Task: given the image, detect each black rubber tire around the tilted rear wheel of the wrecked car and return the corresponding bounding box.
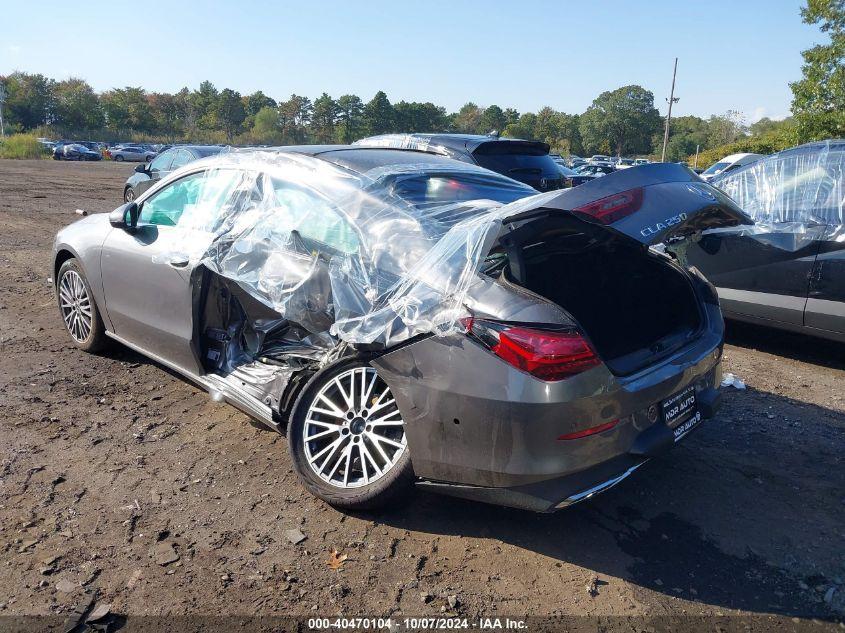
[287,360,415,511]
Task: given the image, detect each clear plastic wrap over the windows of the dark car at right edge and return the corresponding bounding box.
[712,141,845,228]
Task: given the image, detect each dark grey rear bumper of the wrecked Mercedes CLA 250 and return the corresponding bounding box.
[373,304,723,511]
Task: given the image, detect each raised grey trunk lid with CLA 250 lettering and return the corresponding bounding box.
[505,163,754,246]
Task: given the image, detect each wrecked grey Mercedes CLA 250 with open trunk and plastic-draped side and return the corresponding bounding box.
[52,146,750,511]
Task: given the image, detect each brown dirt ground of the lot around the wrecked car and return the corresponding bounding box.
[0,160,845,626]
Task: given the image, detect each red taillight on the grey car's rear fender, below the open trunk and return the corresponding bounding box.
[462,319,601,381]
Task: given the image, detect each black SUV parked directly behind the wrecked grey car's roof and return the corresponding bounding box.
[353,134,566,191]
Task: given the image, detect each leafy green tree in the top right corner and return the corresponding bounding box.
[790,0,845,140]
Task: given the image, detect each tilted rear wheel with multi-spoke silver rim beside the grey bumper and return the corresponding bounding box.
[288,361,413,510]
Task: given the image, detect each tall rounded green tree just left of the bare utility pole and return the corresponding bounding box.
[579,85,661,155]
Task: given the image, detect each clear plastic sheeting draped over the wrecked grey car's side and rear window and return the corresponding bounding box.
[152,151,544,355]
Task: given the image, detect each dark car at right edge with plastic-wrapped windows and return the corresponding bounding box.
[687,141,845,341]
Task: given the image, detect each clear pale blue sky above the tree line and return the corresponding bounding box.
[0,0,825,122]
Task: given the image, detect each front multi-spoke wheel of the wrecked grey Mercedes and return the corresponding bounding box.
[56,259,106,352]
